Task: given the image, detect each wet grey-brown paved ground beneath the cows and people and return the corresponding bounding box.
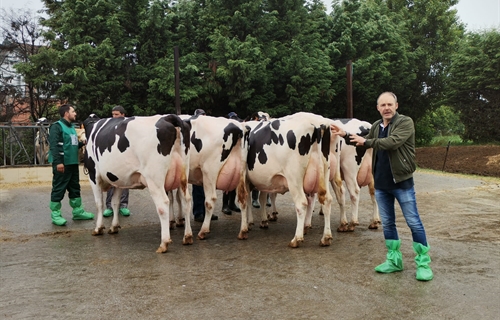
[0,171,500,319]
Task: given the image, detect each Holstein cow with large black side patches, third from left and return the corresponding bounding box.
[238,112,332,248]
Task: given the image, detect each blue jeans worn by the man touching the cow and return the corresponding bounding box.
[375,187,427,246]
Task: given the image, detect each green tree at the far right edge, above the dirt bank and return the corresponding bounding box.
[448,30,500,142]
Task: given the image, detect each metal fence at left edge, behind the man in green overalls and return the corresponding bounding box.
[0,122,50,167]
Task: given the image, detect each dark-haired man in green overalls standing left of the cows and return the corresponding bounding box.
[49,104,94,226]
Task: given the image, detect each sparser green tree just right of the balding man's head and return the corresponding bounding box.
[386,0,464,121]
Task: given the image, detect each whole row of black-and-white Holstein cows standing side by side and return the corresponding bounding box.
[45,112,380,253]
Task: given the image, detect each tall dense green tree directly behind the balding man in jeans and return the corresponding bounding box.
[329,1,416,121]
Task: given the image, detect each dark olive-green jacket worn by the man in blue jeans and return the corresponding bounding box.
[365,112,417,183]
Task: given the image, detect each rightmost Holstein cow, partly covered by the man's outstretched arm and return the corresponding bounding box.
[330,119,380,232]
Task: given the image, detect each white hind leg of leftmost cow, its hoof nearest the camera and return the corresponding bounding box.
[147,184,172,253]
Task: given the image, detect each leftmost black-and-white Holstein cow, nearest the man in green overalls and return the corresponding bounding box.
[84,114,193,253]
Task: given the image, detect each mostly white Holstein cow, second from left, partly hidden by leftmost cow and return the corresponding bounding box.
[172,115,247,240]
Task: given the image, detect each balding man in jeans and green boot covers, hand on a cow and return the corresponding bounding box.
[331,92,433,281]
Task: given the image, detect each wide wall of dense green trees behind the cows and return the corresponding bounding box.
[3,0,463,122]
